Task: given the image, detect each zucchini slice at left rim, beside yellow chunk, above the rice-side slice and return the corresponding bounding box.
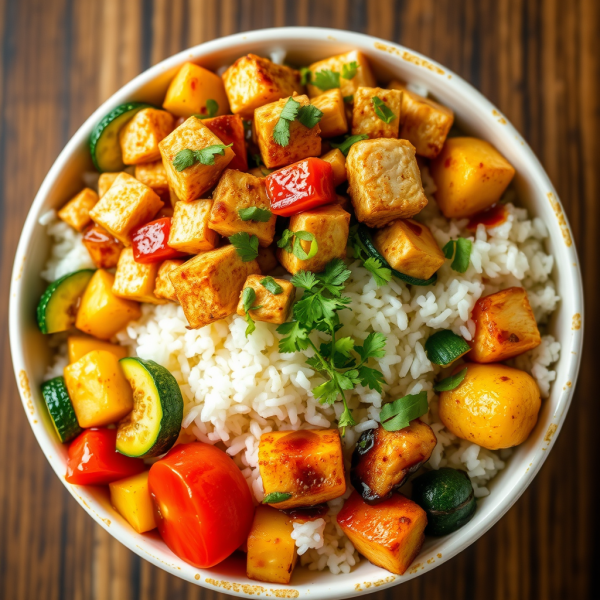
[37,269,95,333]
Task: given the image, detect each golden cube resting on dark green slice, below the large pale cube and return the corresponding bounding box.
[373,219,446,279]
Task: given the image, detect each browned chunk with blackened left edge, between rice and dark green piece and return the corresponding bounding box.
[350,419,437,504]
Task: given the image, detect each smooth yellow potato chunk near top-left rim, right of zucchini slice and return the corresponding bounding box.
[163,63,229,119]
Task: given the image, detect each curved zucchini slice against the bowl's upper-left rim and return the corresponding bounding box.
[90,102,154,173]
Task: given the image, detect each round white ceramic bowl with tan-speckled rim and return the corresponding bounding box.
[10,27,583,600]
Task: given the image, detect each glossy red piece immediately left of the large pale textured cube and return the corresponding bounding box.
[265,158,337,217]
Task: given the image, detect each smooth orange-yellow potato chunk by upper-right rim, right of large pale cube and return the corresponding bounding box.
[430,137,515,219]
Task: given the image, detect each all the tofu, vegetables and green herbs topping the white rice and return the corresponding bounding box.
[37,51,540,584]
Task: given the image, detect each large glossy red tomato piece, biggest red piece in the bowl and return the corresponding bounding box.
[148,442,254,569]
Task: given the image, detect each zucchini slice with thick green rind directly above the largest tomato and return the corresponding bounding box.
[117,357,183,457]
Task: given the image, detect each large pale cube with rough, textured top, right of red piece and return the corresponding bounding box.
[346,138,427,227]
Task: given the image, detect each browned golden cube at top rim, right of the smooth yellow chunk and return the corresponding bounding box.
[223,54,302,119]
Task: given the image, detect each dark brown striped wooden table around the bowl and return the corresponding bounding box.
[0,0,600,600]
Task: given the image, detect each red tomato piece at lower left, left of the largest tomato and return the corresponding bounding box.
[65,428,146,485]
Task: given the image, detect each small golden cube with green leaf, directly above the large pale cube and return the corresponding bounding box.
[352,88,402,139]
